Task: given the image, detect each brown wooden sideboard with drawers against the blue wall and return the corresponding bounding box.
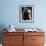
[2,32,44,46]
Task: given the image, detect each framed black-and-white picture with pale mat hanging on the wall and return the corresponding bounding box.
[19,5,34,23]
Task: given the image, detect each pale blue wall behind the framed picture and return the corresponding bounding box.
[0,0,46,31]
